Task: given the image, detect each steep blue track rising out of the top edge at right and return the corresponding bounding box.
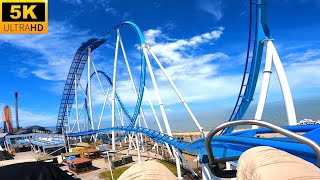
[222,0,271,134]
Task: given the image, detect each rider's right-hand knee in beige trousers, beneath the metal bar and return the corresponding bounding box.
[237,146,320,180]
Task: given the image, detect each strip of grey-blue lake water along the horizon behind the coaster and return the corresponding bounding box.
[47,100,320,132]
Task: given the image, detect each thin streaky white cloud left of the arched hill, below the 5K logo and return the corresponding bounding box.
[0,21,89,81]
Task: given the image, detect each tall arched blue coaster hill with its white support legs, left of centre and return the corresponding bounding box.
[57,21,204,177]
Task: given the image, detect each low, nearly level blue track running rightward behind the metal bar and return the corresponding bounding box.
[68,125,320,164]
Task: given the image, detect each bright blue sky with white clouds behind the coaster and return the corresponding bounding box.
[0,0,320,130]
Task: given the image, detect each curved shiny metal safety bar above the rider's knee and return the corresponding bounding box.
[205,120,320,177]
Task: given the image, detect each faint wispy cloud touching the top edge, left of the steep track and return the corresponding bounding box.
[197,0,223,20]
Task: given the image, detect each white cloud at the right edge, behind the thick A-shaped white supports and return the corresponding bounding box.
[255,49,320,102]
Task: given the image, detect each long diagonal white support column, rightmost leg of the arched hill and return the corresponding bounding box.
[146,45,205,137]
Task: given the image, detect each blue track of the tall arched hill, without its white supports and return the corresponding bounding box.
[56,21,146,134]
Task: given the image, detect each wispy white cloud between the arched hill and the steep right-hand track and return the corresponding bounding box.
[107,27,241,105]
